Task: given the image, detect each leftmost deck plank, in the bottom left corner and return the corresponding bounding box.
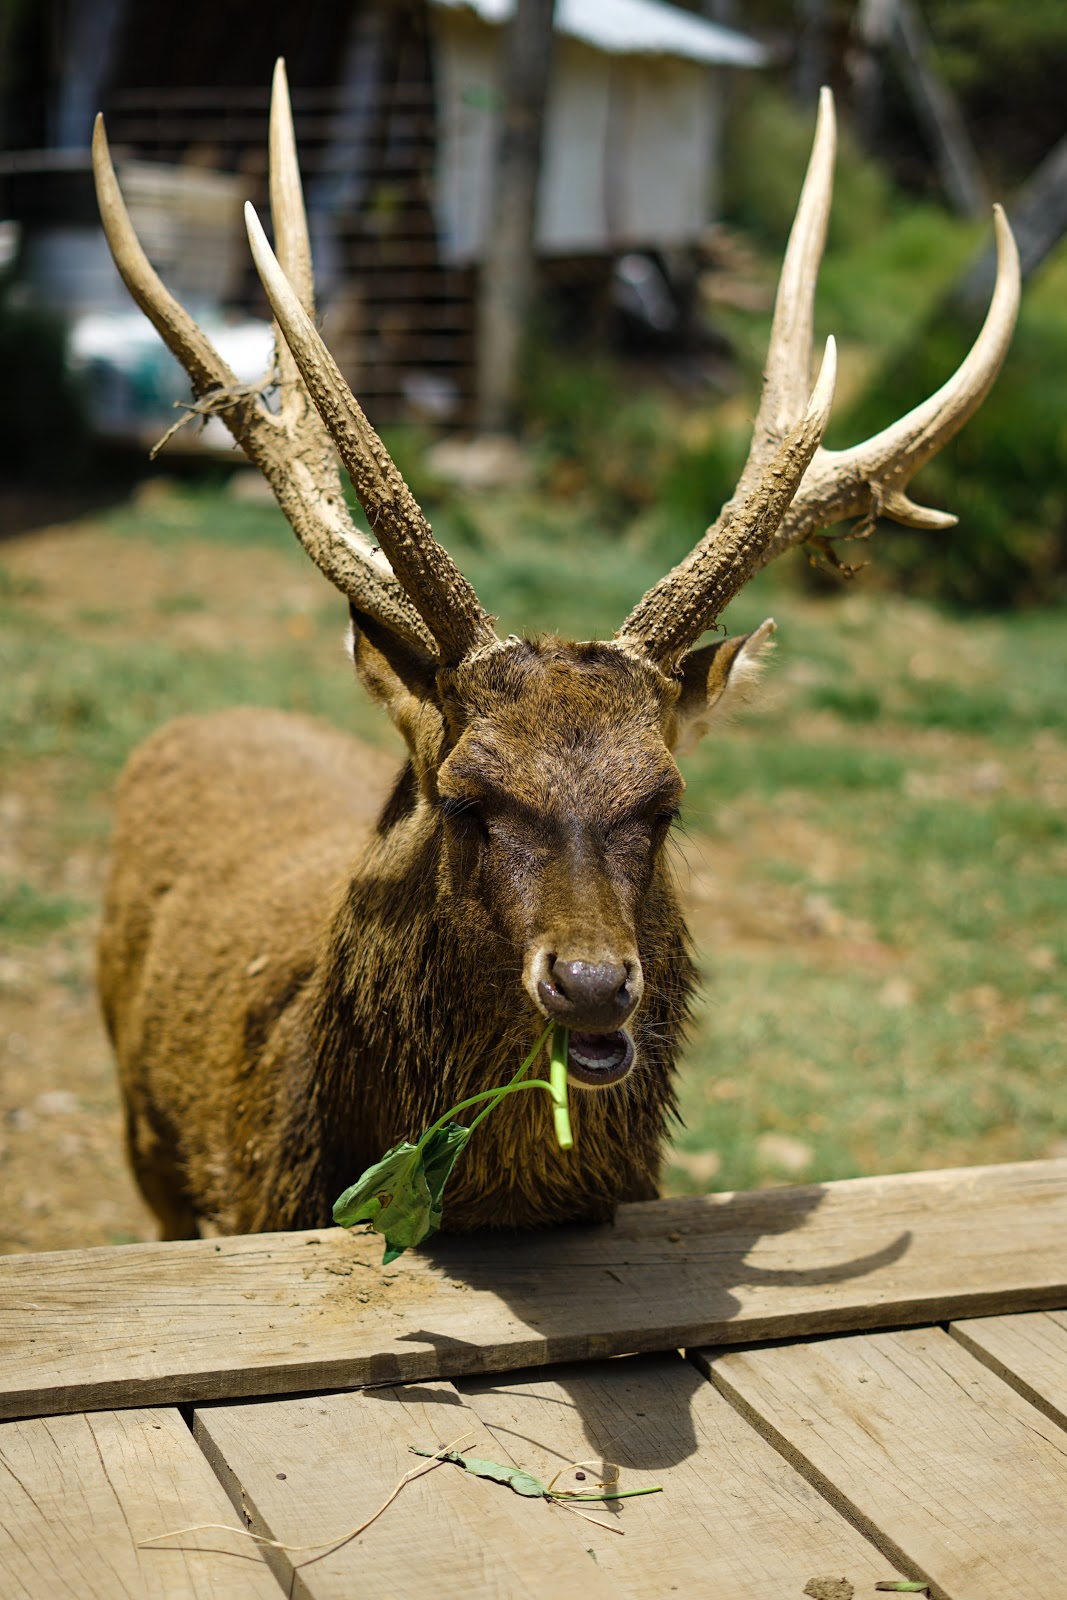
[0,1410,280,1600]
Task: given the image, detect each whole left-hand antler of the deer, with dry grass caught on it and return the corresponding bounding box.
[93,61,496,664]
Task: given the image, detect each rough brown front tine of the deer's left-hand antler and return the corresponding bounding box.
[245,205,496,664]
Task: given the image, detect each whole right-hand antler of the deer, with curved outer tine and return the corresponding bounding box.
[617,90,1019,669]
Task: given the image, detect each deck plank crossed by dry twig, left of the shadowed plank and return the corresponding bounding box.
[195,1382,622,1600]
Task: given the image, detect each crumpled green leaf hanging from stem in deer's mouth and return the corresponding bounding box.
[333,1122,470,1266]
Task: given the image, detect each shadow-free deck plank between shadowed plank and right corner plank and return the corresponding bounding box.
[704,1328,1067,1600]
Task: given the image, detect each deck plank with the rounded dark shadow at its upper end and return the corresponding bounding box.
[461,1354,894,1600]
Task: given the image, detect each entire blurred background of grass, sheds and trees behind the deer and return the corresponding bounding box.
[0,0,1067,1250]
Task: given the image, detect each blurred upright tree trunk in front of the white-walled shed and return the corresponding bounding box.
[477,0,555,434]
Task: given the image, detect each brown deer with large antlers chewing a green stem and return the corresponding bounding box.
[94,64,1019,1238]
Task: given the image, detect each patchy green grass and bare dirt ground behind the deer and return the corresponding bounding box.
[0,480,1067,1250]
